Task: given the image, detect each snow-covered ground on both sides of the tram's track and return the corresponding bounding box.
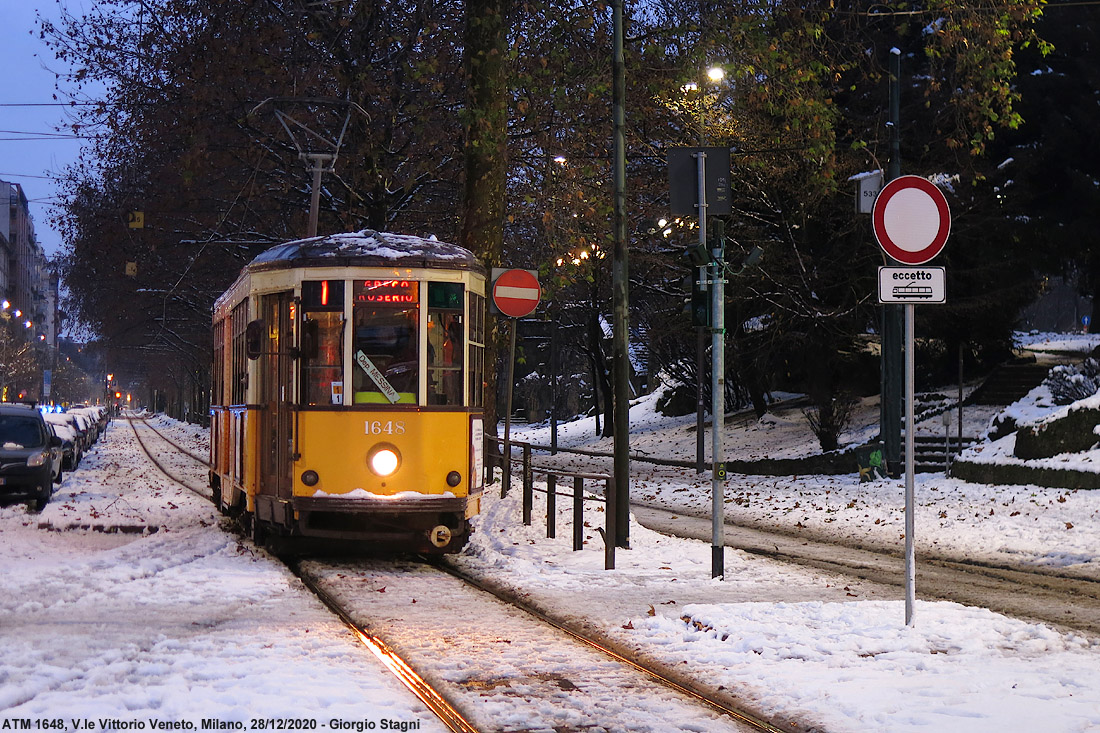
[0,334,1100,733]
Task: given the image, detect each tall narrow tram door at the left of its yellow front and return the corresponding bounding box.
[260,291,294,499]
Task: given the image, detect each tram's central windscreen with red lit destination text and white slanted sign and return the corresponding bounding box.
[351,280,420,405]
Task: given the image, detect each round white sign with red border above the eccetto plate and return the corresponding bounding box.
[871,176,952,265]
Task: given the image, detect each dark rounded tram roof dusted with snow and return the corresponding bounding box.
[249,229,479,269]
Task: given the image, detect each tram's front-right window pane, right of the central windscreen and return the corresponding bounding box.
[428,283,465,405]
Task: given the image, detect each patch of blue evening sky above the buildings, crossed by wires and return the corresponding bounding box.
[0,0,89,256]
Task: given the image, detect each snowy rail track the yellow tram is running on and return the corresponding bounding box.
[130,420,792,733]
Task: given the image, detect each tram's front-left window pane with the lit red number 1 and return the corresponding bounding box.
[301,280,344,405]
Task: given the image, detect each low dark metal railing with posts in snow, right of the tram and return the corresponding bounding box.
[485,436,615,570]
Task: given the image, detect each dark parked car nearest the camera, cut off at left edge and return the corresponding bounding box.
[0,403,63,512]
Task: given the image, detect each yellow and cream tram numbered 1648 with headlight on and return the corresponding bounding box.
[210,230,485,553]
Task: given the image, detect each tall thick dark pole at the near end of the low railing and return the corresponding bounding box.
[607,0,630,548]
